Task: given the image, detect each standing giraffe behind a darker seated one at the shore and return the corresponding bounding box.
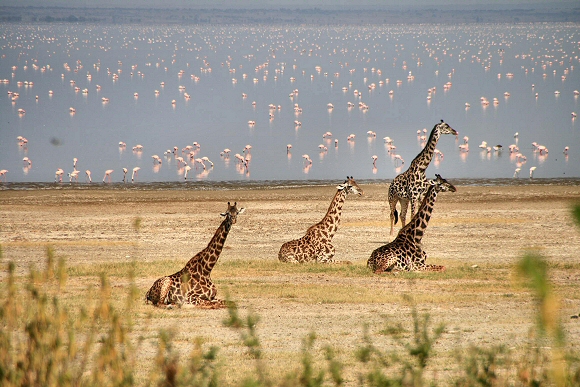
[388,120,459,235]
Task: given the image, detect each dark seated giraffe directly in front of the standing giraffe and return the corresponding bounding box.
[367,175,456,273]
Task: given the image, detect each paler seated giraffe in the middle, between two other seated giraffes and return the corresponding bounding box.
[278,176,364,263]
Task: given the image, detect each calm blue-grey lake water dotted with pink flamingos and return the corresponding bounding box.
[0,23,580,183]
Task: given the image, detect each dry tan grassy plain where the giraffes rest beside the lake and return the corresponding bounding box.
[0,181,580,385]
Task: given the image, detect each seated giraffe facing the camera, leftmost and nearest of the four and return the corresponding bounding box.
[145,202,245,309]
